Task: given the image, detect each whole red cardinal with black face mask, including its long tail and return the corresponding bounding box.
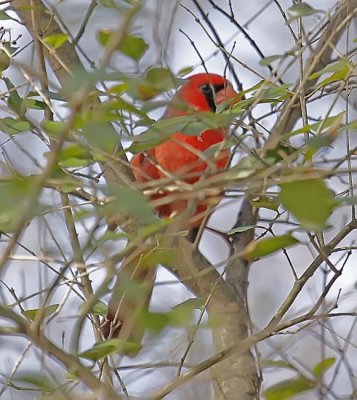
[102,73,239,342]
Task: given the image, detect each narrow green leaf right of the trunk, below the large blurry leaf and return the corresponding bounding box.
[244,233,299,260]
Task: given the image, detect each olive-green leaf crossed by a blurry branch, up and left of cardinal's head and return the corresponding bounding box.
[98,29,149,61]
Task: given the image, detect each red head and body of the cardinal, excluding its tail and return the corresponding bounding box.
[131,73,238,228]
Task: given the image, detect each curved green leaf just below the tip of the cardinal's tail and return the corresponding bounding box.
[79,339,141,361]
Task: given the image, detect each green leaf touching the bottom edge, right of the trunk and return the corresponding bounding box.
[263,377,315,400]
